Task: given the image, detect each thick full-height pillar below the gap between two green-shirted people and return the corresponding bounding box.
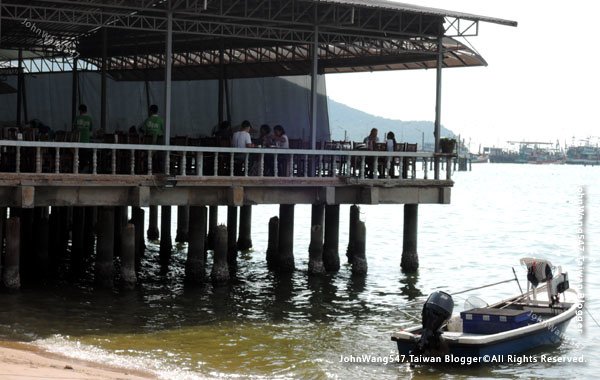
[96,207,115,288]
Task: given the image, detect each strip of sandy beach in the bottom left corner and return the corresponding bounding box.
[0,341,156,380]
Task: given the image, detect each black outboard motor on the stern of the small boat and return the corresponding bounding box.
[412,291,454,355]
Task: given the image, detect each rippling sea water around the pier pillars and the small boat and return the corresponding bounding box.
[0,164,600,379]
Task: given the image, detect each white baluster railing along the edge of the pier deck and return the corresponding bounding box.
[0,140,453,180]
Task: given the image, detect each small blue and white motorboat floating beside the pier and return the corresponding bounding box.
[392,258,583,365]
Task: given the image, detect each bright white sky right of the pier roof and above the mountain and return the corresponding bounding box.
[326,0,600,150]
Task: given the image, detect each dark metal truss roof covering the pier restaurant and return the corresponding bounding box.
[0,0,516,80]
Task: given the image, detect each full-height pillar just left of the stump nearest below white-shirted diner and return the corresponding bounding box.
[185,206,206,283]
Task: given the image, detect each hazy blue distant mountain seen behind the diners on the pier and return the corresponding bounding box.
[327,98,455,146]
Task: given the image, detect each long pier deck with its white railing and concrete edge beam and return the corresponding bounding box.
[0,140,453,208]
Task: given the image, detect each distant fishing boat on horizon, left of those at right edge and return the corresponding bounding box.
[489,141,566,164]
